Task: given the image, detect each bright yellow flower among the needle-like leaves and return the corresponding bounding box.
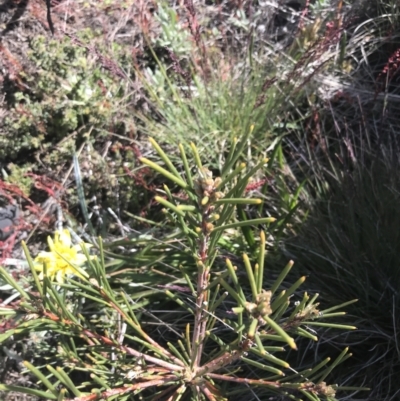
[34,230,91,283]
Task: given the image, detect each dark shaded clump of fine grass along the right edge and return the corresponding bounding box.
[287,144,400,400]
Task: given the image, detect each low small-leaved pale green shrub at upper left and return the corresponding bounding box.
[0,31,121,158]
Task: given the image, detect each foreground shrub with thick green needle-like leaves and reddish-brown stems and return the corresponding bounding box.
[0,136,362,401]
